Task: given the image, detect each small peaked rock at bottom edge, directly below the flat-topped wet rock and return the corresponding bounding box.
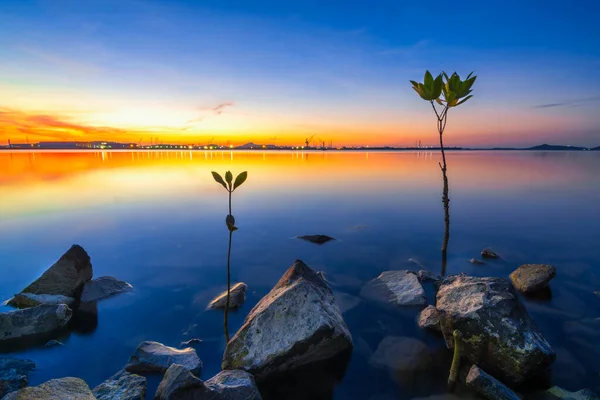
[154,364,205,400]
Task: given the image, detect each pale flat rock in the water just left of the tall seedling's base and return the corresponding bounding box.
[360,270,427,306]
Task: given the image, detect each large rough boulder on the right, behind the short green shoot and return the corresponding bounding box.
[436,275,555,383]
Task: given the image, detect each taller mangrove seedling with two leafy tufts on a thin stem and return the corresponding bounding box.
[410,71,477,275]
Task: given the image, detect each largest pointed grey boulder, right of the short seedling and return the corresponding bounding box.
[222,260,352,380]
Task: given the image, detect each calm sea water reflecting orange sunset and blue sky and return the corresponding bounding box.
[0,151,600,399]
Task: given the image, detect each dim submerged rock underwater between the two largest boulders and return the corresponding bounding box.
[369,336,432,374]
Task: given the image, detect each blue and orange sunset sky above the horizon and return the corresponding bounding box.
[0,0,600,147]
